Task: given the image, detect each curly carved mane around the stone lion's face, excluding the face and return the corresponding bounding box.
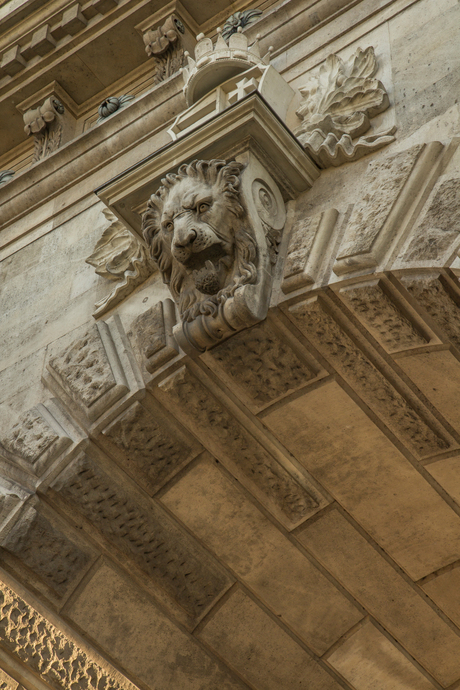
[142,160,257,321]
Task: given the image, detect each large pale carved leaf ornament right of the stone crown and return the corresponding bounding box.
[295,46,395,168]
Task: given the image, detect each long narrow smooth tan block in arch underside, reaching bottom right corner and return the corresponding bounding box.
[299,510,460,688]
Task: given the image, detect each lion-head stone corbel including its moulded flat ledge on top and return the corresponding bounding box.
[98,91,319,356]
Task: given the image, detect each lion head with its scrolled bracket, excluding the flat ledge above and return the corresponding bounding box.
[142,153,285,355]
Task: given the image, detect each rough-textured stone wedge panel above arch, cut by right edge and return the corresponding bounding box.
[404,179,460,261]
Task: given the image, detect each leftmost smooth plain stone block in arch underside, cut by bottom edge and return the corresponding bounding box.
[67,566,247,690]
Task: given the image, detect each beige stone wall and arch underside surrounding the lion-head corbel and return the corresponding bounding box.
[0,0,460,690]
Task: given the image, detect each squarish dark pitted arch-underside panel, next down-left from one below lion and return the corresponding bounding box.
[103,402,191,493]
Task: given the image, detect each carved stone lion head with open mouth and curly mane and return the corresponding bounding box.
[142,160,257,322]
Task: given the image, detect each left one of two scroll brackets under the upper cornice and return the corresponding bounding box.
[23,96,64,163]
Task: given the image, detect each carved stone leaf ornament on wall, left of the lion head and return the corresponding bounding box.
[86,208,156,316]
